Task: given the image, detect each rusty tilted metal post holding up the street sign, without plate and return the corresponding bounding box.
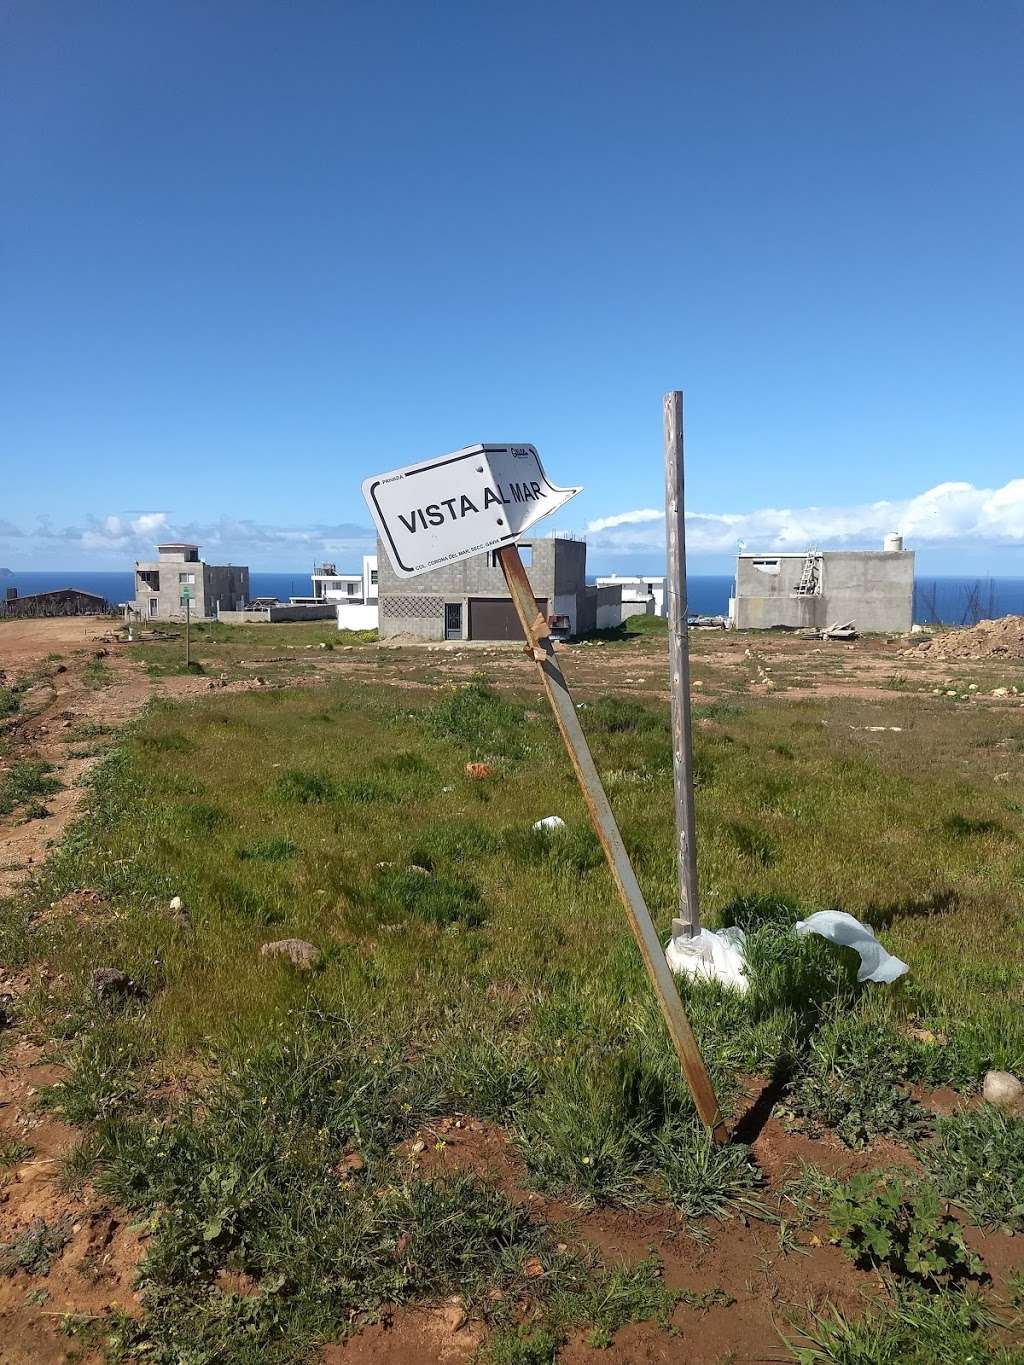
[497,545,728,1143]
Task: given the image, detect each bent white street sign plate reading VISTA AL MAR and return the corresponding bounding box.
[363,445,580,579]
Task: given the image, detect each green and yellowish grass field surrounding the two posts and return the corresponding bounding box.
[3,666,1024,1365]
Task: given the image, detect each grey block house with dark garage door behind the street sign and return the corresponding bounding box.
[377,536,621,640]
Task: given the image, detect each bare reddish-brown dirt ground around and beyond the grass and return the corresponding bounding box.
[0,618,1024,1365]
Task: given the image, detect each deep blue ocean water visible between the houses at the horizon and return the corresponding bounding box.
[0,569,1024,625]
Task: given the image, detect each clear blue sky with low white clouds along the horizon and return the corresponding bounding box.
[0,0,1024,573]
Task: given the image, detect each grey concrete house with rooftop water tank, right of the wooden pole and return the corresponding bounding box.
[729,535,913,631]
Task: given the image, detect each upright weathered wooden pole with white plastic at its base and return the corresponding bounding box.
[662,389,700,938]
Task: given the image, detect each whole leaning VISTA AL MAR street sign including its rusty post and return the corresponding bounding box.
[363,444,726,1143]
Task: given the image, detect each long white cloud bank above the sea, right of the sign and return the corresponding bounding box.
[586,479,1024,554]
